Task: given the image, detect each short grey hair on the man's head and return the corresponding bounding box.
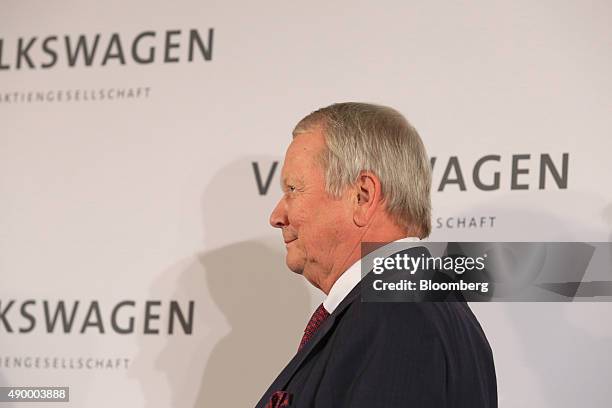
[293,102,431,238]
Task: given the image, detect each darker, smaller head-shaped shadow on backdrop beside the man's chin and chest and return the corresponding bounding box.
[194,243,310,408]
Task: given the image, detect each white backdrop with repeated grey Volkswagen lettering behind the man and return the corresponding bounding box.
[0,0,612,408]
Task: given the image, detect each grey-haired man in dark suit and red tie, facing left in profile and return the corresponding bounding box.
[257,103,497,408]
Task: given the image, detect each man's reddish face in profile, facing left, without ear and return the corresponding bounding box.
[270,128,352,287]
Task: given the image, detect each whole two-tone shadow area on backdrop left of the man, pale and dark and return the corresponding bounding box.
[130,157,312,408]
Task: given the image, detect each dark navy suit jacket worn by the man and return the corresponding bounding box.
[257,247,497,408]
